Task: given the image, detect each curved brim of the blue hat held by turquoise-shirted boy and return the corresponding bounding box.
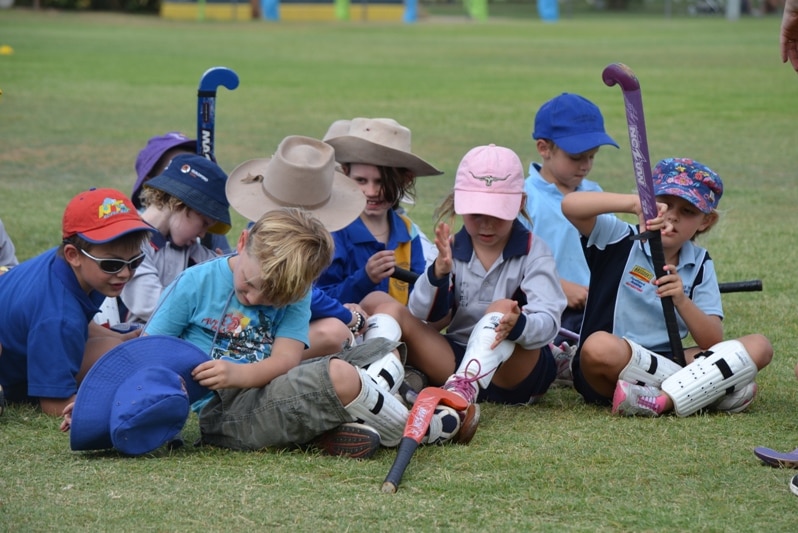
[69,335,210,451]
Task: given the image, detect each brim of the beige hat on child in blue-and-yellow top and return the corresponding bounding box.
[324,135,443,177]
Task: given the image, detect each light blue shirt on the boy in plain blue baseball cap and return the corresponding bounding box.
[519,163,601,287]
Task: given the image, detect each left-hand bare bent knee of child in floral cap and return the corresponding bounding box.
[579,331,632,398]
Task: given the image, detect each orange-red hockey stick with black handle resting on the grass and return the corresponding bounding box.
[382,387,468,493]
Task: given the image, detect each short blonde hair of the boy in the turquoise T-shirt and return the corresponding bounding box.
[244,207,334,307]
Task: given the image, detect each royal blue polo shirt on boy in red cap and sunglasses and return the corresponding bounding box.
[0,248,105,401]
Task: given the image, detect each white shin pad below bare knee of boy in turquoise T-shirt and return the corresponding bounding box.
[345,369,408,447]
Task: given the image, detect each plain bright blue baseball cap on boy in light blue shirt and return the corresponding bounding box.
[532,93,618,154]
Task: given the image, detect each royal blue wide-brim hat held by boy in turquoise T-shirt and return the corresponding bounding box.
[69,335,209,455]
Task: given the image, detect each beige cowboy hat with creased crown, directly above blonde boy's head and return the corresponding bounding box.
[226,135,366,231]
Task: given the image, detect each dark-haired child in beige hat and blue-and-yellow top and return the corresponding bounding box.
[318,118,443,311]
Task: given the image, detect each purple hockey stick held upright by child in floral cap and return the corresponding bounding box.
[601,63,684,365]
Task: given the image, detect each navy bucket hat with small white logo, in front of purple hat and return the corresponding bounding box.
[144,154,231,235]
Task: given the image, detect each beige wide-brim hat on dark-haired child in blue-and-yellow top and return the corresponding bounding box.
[325,118,443,177]
